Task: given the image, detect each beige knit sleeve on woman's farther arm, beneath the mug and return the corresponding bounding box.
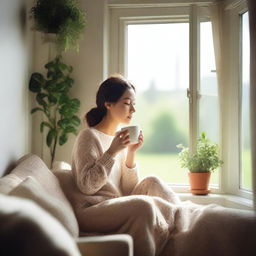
[121,153,139,195]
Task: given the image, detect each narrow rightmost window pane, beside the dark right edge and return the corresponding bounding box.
[240,12,252,190]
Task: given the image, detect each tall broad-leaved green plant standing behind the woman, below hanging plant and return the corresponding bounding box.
[29,55,80,167]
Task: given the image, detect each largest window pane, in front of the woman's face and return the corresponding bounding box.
[127,23,189,184]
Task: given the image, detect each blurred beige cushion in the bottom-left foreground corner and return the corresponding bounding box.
[0,194,80,256]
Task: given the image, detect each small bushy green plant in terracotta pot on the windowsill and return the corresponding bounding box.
[177,132,223,195]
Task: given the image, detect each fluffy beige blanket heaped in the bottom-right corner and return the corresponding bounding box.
[161,201,256,256]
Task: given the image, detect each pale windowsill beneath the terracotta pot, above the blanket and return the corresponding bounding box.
[178,193,253,210]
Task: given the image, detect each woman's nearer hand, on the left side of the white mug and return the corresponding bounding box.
[107,130,130,157]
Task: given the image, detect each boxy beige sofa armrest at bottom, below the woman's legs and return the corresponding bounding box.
[76,234,133,256]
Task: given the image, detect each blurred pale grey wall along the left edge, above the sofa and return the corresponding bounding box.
[0,0,32,176]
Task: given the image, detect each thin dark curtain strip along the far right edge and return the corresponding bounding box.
[248,0,256,211]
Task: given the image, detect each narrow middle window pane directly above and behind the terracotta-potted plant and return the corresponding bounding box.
[199,22,219,185]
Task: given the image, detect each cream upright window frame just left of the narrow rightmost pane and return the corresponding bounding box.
[223,0,253,200]
